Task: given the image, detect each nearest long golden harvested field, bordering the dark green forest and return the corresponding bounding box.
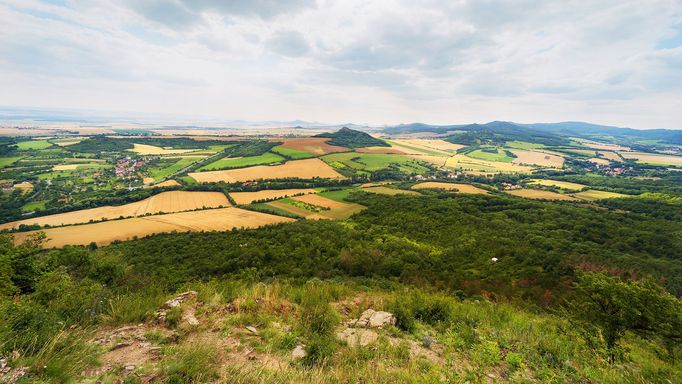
[15,208,293,248]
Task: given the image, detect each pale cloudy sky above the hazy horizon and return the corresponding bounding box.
[0,0,682,129]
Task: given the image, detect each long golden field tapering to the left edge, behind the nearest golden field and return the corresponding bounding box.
[0,191,230,230]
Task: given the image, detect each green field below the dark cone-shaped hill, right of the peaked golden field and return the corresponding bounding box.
[321,152,427,173]
